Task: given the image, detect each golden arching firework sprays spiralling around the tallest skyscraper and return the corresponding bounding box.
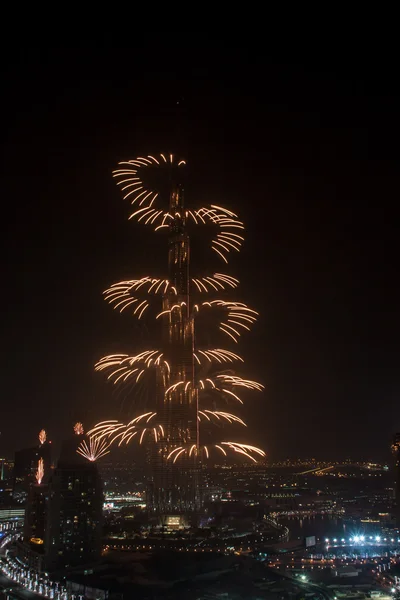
[90,154,265,464]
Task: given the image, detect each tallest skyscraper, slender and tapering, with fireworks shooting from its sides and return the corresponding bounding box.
[148,182,200,515]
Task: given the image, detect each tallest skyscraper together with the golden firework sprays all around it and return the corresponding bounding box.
[89,154,265,522]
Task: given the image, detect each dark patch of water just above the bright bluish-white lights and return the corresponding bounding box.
[279,515,358,540]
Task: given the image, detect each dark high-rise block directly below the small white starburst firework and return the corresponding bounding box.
[45,436,103,571]
